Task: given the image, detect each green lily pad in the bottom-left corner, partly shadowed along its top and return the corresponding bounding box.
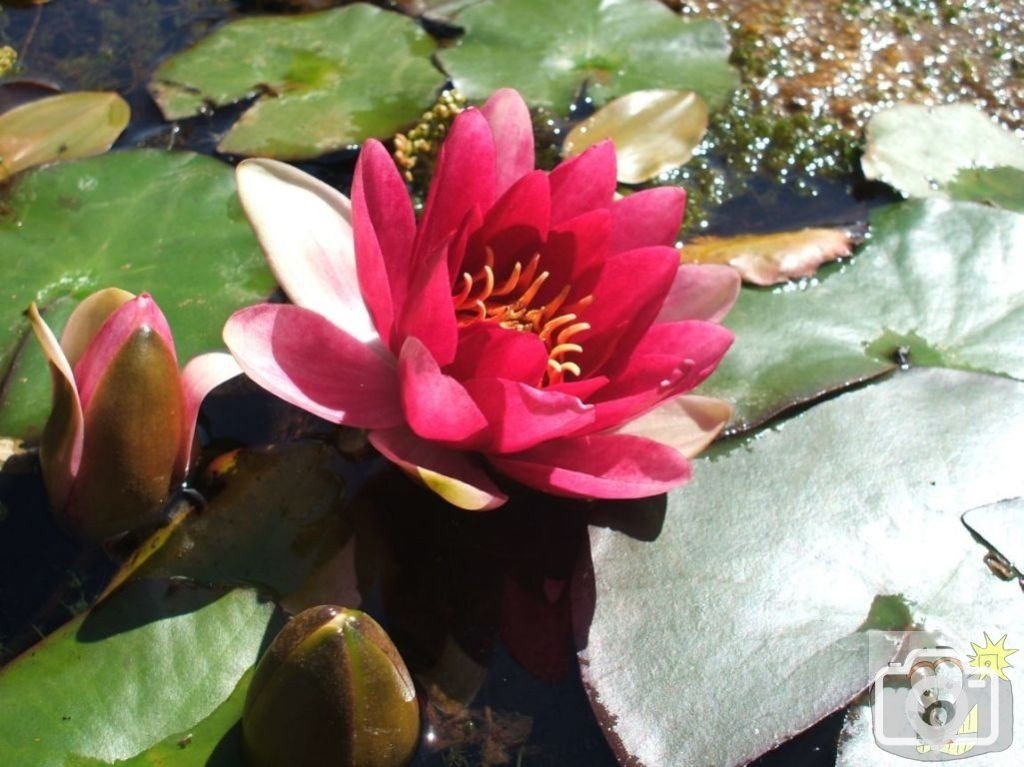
[0,581,274,767]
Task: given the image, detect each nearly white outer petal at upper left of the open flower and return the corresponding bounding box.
[236,160,377,341]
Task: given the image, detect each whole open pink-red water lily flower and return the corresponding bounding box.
[224,90,738,509]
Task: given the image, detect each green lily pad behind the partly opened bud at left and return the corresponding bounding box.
[0,151,274,437]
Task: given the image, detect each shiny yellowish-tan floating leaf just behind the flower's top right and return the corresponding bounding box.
[562,90,708,183]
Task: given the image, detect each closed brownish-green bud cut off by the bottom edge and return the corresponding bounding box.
[242,605,420,767]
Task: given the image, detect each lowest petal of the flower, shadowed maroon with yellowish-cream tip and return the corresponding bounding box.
[370,426,508,511]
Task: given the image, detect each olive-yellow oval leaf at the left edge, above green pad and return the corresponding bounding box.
[0,92,131,181]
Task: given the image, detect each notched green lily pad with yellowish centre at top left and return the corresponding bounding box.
[150,3,444,160]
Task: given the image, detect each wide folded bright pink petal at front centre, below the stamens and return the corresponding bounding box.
[465,378,594,453]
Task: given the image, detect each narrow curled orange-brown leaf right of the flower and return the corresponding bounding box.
[681,228,851,286]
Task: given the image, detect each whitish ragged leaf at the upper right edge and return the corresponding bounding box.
[860,103,1024,197]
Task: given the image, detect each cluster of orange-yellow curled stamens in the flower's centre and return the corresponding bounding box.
[452,248,594,386]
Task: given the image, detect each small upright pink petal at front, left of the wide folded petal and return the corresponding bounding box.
[398,338,487,448]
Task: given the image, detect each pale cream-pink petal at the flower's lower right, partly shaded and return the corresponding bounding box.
[615,394,732,458]
